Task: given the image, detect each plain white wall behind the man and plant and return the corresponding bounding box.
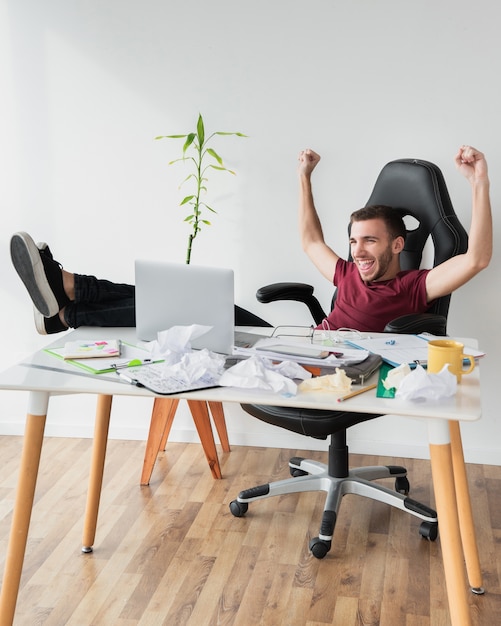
[0,0,501,464]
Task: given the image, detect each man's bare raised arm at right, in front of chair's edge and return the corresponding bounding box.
[426,146,492,302]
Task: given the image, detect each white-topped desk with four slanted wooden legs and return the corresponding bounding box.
[0,328,482,626]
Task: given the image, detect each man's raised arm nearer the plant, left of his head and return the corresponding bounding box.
[298,149,339,282]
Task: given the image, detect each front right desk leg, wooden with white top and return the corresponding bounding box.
[430,420,471,626]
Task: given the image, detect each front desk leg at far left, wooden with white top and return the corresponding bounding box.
[0,391,49,626]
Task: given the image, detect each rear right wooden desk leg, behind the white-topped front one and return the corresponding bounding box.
[449,421,485,594]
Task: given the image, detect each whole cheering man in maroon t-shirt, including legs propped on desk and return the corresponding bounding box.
[11,146,492,334]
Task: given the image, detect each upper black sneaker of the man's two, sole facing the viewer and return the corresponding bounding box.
[10,232,70,318]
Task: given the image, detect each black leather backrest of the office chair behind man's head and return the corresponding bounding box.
[338,159,468,317]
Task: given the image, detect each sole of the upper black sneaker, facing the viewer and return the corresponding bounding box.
[10,232,59,317]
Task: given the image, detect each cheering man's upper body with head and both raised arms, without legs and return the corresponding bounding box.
[298,146,492,332]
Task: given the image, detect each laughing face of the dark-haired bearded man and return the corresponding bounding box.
[350,219,404,282]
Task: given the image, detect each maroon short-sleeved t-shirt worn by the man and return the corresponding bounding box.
[319,259,430,333]
